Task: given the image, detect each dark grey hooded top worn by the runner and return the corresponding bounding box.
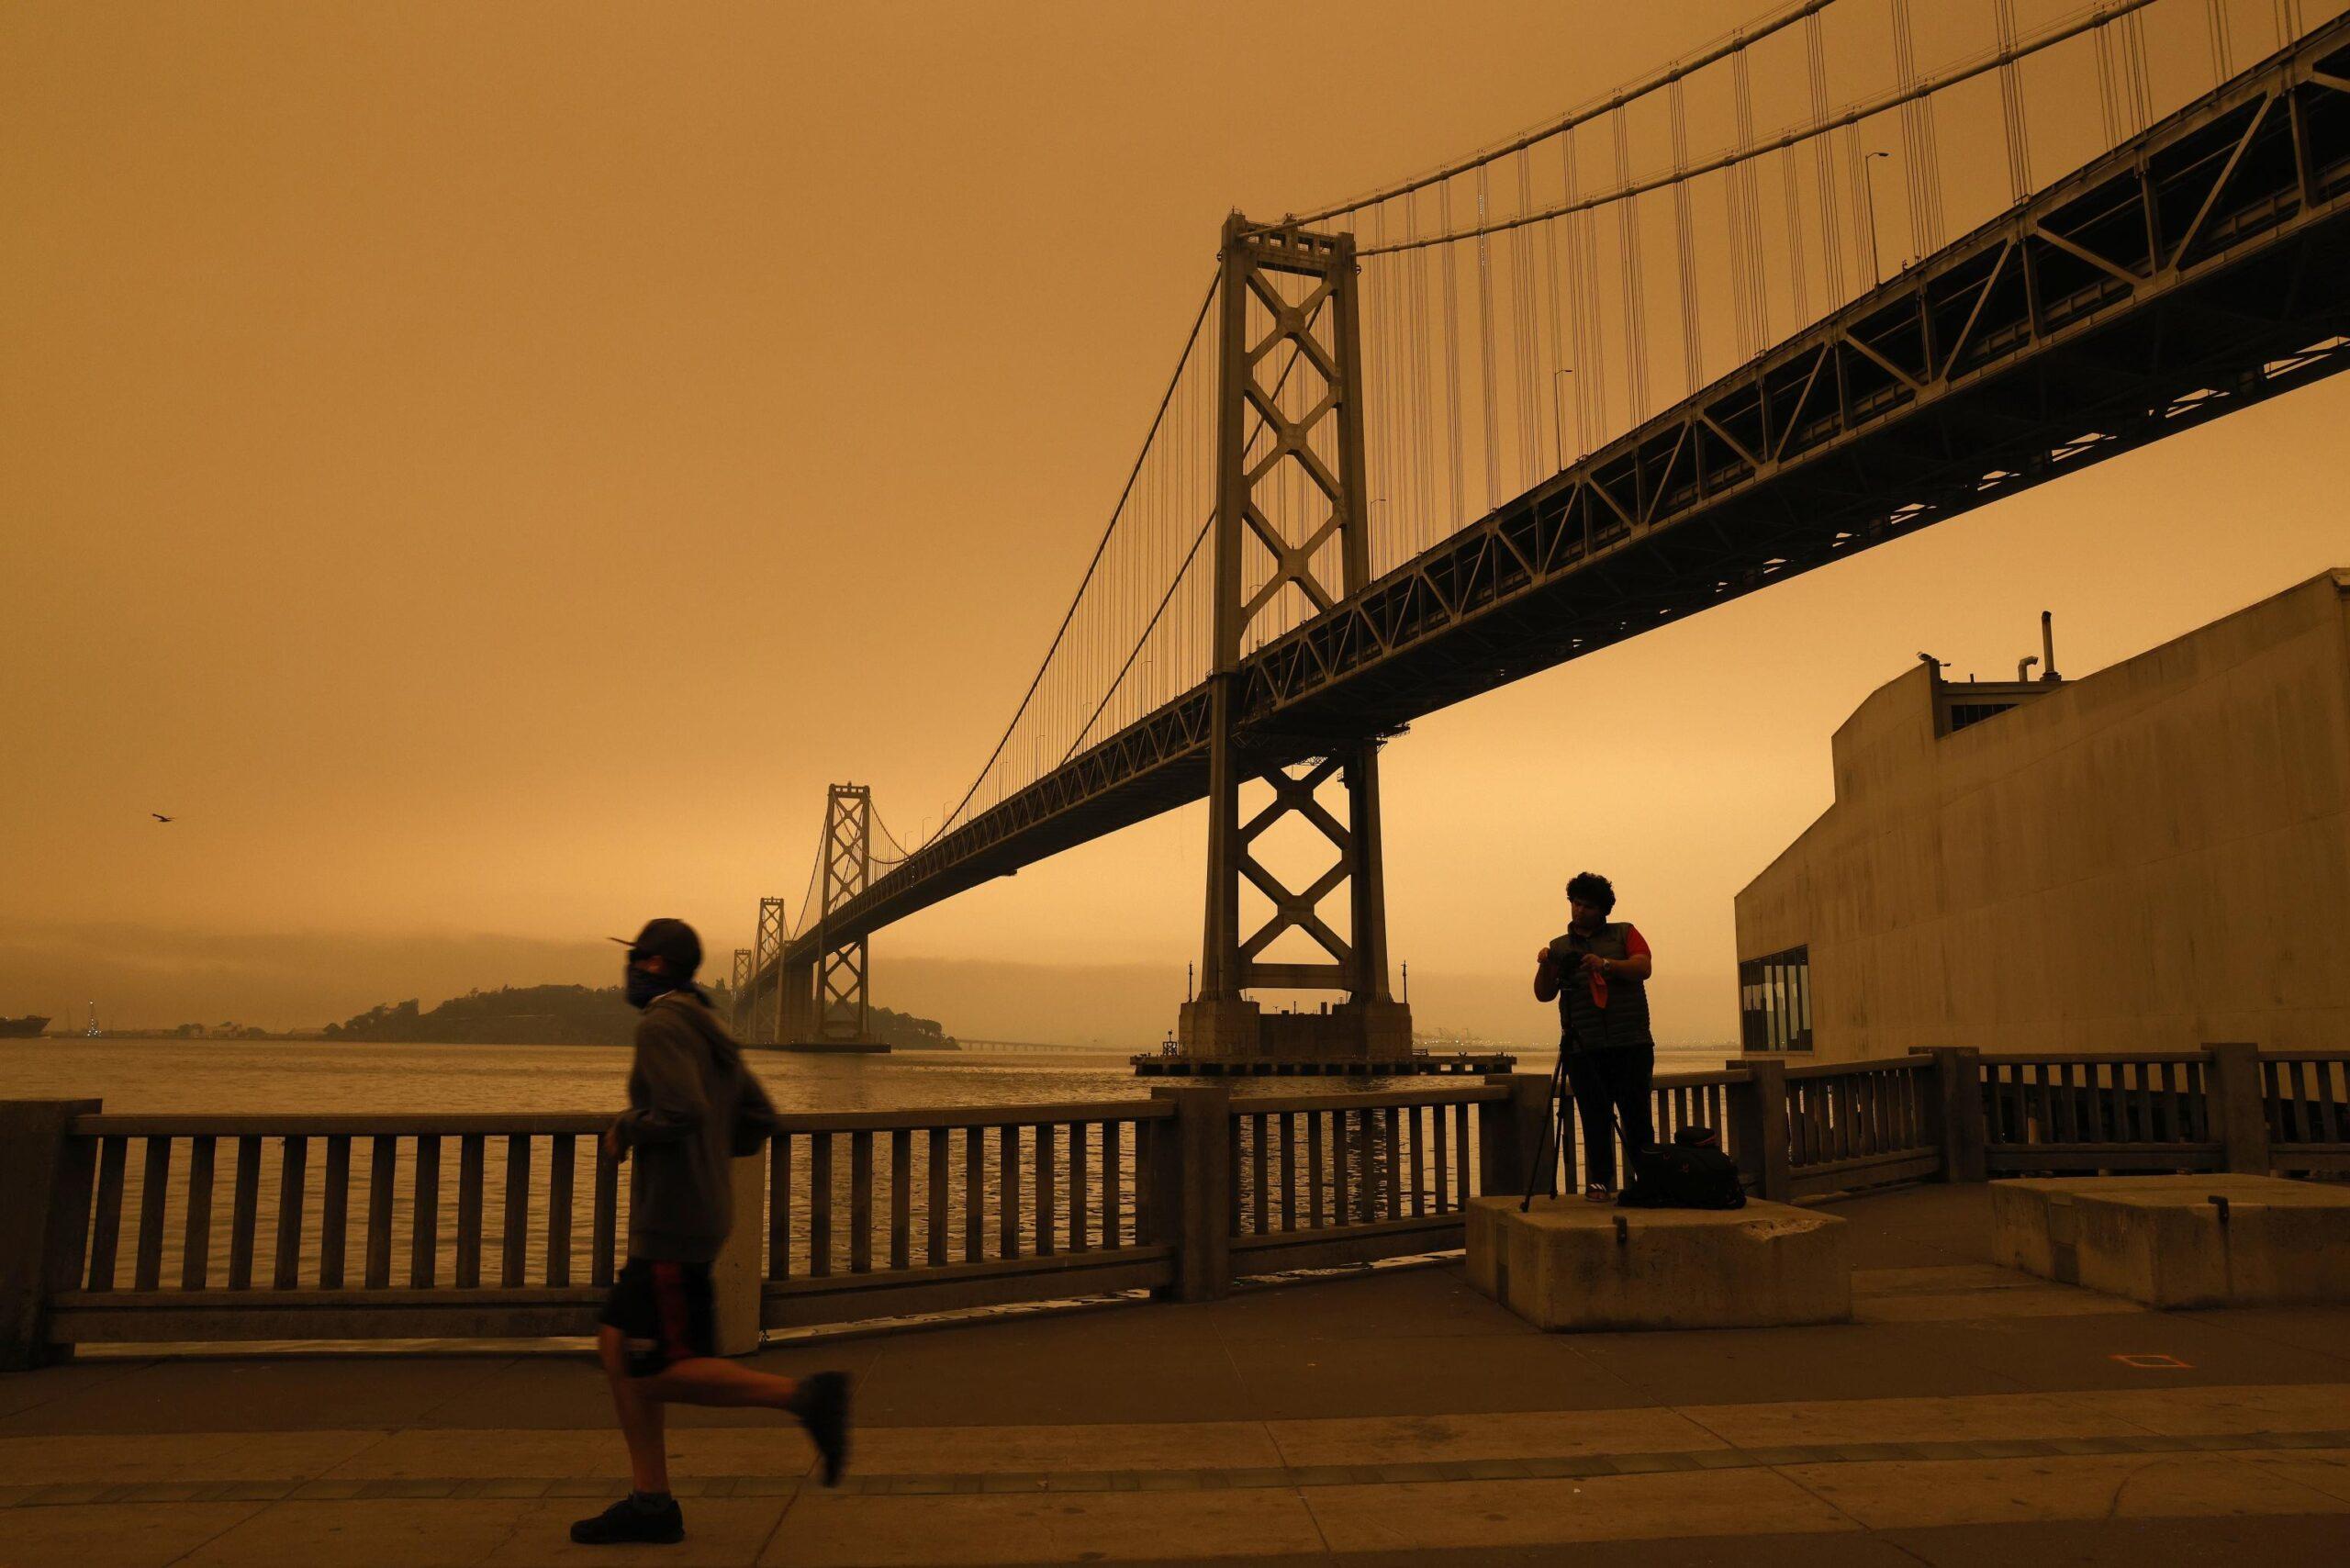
[621,990,776,1262]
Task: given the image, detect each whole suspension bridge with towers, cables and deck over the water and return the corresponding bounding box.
[735,0,2350,1060]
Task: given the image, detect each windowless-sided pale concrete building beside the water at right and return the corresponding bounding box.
[1737,569,2350,1060]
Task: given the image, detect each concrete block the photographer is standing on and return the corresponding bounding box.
[1466,1196,1852,1328]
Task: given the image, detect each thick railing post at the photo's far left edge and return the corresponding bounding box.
[0,1100,104,1372]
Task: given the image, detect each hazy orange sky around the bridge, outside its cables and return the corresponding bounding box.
[0,0,2350,1039]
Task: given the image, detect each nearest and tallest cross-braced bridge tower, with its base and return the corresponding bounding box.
[1182,211,1413,1060]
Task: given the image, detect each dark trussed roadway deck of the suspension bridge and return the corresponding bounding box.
[779,18,2350,980]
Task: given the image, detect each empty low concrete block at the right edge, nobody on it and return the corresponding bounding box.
[1990,1173,2350,1307]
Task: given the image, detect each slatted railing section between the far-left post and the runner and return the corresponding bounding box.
[50,1112,625,1342]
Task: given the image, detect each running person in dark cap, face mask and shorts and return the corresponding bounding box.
[571,919,848,1547]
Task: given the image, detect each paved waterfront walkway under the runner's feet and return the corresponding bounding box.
[0,1187,2350,1568]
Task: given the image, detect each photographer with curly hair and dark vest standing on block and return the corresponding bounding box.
[1535,872,1657,1204]
